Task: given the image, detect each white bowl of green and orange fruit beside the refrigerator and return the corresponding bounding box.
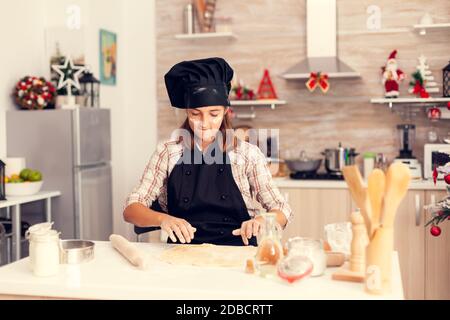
[5,168,44,197]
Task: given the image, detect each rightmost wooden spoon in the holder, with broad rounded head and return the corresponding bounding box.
[382,162,411,228]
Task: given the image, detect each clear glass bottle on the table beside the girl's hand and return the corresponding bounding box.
[255,212,283,277]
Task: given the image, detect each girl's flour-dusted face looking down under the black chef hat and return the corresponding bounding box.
[186,106,228,142]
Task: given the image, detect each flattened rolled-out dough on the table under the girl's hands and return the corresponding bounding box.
[160,243,257,267]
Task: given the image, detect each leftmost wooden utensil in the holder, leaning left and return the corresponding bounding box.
[342,165,372,238]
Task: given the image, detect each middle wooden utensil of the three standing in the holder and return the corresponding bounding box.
[367,169,386,238]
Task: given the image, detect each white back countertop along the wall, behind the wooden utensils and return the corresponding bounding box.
[273,177,446,190]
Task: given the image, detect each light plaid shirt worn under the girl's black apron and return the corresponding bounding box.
[125,140,292,223]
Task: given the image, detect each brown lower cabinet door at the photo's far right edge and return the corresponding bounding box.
[425,191,450,300]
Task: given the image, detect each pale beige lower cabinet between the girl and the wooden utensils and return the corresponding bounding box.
[280,188,350,241]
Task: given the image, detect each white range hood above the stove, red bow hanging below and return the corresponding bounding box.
[283,0,360,79]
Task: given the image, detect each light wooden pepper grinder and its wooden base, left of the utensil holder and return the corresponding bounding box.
[331,210,369,282]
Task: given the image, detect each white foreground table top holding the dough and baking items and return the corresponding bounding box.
[0,242,404,300]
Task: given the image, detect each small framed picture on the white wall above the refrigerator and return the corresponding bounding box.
[100,29,117,86]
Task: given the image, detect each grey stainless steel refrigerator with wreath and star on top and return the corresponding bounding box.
[6,108,113,240]
